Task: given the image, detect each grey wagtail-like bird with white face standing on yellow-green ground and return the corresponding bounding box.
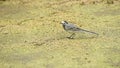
[61,21,98,39]
